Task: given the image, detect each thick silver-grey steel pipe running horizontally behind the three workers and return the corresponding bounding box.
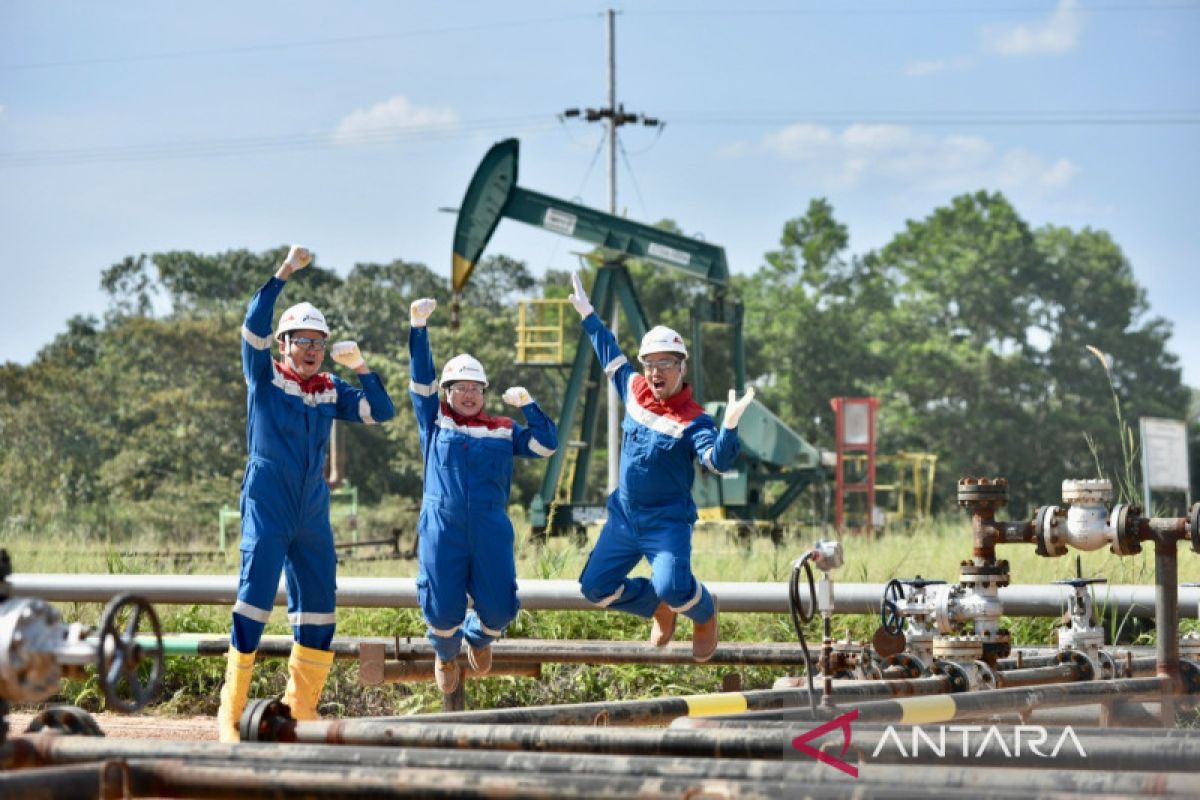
[8,573,1200,618]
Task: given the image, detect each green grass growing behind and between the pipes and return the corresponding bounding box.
[2,509,1200,716]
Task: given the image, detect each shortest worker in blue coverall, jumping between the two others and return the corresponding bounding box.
[408,297,558,694]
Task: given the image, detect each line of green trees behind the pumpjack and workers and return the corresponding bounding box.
[0,192,1200,531]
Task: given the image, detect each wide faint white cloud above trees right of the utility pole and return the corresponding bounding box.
[724,122,1079,193]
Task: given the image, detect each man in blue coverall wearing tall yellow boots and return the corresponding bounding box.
[217,245,396,741]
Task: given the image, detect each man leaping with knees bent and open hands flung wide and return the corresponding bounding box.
[569,275,754,661]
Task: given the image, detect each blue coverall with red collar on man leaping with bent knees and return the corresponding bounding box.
[580,313,740,622]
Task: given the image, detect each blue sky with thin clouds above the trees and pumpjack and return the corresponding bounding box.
[0,0,1200,386]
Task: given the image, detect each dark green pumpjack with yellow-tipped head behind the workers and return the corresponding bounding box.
[451,139,829,535]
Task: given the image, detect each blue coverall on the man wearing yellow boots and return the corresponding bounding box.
[230,276,396,652]
